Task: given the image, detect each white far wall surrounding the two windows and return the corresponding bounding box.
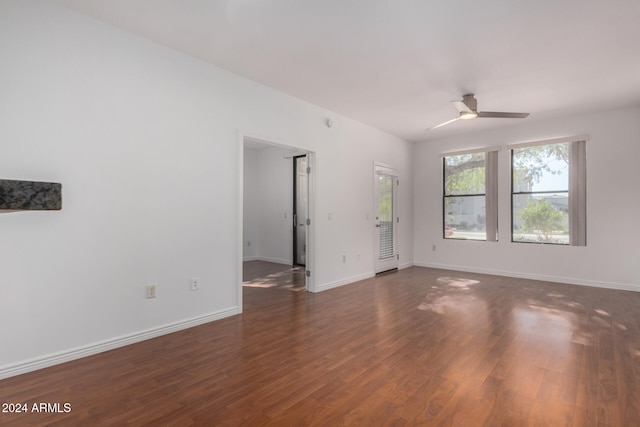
[415,108,640,291]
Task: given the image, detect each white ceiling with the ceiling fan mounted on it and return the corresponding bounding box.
[52,0,640,141]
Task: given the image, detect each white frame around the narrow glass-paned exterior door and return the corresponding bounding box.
[373,162,400,274]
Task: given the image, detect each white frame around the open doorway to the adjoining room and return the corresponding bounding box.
[236,131,317,313]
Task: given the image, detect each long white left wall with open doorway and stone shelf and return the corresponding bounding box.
[0,0,413,377]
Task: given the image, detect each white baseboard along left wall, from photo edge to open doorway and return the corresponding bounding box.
[0,307,240,380]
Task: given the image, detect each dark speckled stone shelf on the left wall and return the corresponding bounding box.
[0,179,62,211]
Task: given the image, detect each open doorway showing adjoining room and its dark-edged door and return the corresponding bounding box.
[238,136,315,309]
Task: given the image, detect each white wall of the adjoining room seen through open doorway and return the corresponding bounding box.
[243,147,293,265]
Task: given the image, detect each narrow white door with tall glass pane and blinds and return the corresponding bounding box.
[374,164,400,273]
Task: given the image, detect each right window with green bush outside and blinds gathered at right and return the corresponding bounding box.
[509,138,586,246]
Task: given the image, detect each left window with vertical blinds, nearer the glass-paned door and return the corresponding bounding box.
[442,149,498,241]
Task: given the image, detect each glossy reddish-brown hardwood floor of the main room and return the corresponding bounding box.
[0,267,640,427]
